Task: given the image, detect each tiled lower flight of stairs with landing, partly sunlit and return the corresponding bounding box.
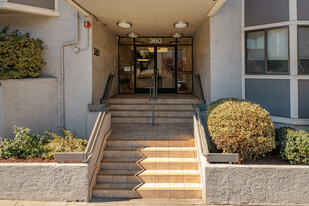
[93,123,202,198]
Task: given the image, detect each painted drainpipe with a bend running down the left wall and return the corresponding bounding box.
[60,11,79,129]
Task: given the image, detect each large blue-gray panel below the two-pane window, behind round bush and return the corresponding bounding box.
[245,79,290,117]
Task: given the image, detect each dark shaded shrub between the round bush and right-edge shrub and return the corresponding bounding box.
[275,127,295,159]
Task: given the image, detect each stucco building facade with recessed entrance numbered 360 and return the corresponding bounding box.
[0,0,309,138]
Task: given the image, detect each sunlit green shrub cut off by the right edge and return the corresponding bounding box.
[284,130,309,164]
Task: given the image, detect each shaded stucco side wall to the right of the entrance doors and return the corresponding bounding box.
[193,18,211,104]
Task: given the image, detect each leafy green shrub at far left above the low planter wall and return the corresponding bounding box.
[0,125,47,159]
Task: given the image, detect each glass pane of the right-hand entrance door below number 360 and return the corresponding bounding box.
[157,47,176,91]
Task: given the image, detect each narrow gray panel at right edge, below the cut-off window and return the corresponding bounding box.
[298,80,309,119]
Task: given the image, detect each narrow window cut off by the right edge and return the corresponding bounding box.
[298,26,309,75]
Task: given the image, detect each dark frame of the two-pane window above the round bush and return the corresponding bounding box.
[245,26,290,75]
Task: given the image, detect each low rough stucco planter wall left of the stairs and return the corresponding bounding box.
[0,163,88,201]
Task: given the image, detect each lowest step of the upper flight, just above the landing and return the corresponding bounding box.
[112,114,193,124]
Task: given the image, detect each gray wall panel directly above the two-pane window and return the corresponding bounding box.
[245,0,288,26]
